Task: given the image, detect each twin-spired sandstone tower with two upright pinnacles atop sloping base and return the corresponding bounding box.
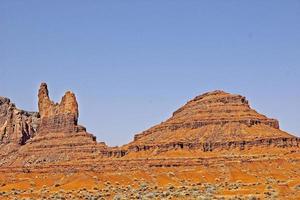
[38,83,85,133]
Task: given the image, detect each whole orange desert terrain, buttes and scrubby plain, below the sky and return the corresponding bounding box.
[0,83,300,199]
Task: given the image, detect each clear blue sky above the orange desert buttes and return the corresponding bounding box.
[0,0,300,145]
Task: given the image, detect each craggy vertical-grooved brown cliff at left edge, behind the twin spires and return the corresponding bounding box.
[0,97,39,145]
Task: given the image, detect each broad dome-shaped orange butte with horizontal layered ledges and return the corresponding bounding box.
[126,91,299,151]
